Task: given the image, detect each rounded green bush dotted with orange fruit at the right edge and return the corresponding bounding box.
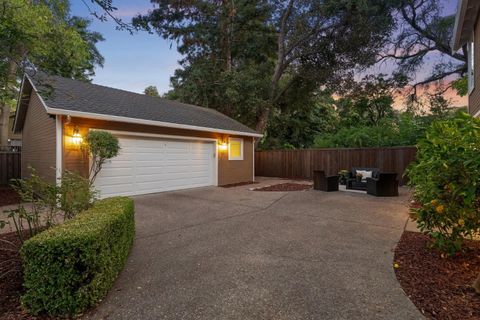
[407,113,480,254]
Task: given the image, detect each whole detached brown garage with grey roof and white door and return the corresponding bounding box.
[14,73,262,197]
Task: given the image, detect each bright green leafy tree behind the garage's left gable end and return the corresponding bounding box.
[0,0,103,145]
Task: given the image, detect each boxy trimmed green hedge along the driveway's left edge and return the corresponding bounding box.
[20,197,135,315]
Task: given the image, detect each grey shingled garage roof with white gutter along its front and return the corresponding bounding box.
[16,72,261,136]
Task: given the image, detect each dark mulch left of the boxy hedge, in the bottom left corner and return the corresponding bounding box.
[0,232,51,320]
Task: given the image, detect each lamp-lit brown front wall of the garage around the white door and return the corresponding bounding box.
[63,118,253,185]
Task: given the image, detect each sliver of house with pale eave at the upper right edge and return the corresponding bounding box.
[452,0,480,117]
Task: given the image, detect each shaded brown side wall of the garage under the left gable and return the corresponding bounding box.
[22,92,55,182]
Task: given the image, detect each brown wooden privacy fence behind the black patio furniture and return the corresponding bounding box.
[255,147,417,183]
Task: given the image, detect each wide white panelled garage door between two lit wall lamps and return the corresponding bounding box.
[95,136,215,198]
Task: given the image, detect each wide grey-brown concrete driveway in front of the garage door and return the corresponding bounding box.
[85,180,422,320]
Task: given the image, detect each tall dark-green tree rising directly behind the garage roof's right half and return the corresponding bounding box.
[133,0,392,132]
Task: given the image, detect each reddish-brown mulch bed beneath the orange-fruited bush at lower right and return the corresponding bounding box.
[395,231,480,320]
